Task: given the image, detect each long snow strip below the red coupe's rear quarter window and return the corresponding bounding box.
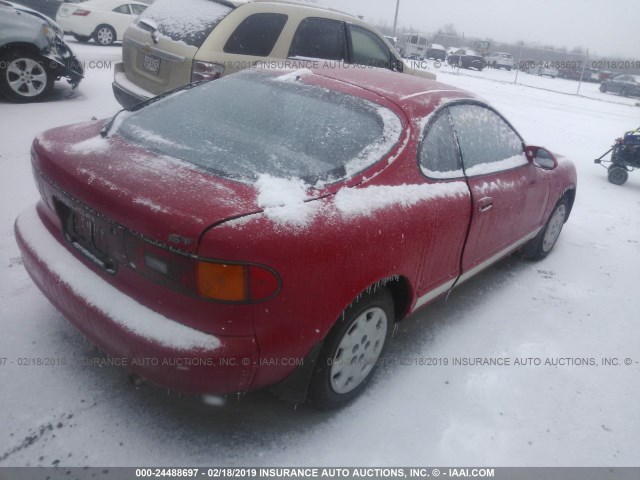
[334,182,469,216]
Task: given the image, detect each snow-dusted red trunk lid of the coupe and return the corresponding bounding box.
[33,122,261,253]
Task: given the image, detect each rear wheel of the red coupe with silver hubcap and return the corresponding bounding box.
[307,288,394,410]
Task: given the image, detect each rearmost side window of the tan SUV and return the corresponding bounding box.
[224,13,288,57]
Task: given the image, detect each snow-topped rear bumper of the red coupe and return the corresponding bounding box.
[15,203,257,394]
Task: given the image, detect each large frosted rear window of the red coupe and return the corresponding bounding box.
[118,71,402,184]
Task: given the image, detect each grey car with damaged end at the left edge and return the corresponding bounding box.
[0,2,84,102]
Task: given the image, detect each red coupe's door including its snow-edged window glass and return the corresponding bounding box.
[449,103,535,279]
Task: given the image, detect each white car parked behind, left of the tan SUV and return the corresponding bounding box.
[56,0,148,45]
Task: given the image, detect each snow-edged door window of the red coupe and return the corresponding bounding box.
[449,105,528,176]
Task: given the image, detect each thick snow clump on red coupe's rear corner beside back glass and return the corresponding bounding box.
[255,174,316,227]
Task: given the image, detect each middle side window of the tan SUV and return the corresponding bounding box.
[289,18,346,60]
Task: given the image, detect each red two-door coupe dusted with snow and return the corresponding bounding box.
[15,65,576,409]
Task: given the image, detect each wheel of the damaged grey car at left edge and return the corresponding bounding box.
[0,50,55,103]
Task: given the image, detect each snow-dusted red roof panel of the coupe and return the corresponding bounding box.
[282,65,479,118]
